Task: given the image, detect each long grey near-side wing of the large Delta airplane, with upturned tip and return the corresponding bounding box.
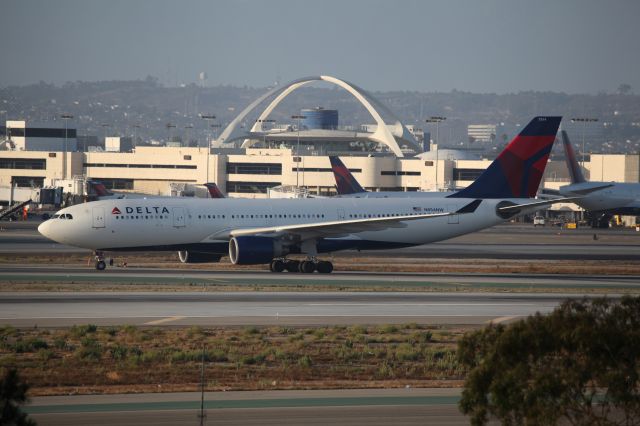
[230,200,482,240]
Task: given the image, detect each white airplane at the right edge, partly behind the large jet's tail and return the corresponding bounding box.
[558,130,640,227]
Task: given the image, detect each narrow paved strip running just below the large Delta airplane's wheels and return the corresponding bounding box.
[0,265,640,291]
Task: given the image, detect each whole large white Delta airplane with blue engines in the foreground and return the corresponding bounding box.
[38,117,567,273]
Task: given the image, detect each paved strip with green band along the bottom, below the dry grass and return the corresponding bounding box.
[27,389,480,426]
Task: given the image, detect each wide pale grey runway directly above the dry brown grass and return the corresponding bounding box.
[0,292,600,327]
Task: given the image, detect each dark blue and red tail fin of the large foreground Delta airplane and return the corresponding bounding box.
[449,117,562,198]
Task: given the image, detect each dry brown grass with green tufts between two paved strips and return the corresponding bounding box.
[0,324,464,395]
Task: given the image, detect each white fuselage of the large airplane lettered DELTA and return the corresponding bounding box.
[39,197,516,250]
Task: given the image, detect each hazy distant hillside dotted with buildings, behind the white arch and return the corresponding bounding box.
[0,77,640,152]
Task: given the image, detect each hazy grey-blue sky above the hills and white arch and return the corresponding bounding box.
[0,0,640,93]
